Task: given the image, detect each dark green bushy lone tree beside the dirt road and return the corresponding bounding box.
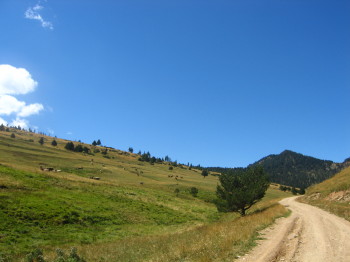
[215,166,270,216]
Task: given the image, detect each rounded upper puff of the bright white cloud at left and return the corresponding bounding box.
[0,65,38,95]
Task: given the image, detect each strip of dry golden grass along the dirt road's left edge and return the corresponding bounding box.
[41,204,288,262]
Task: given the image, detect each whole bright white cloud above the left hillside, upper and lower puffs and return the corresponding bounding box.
[0,65,44,128]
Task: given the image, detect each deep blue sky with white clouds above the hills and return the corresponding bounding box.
[0,0,350,167]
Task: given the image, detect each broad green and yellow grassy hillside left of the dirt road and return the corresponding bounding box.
[0,130,287,261]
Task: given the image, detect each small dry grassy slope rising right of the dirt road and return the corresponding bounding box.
[300,167,350,221]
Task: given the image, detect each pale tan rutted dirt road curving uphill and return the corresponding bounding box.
[237,197,350,262]
